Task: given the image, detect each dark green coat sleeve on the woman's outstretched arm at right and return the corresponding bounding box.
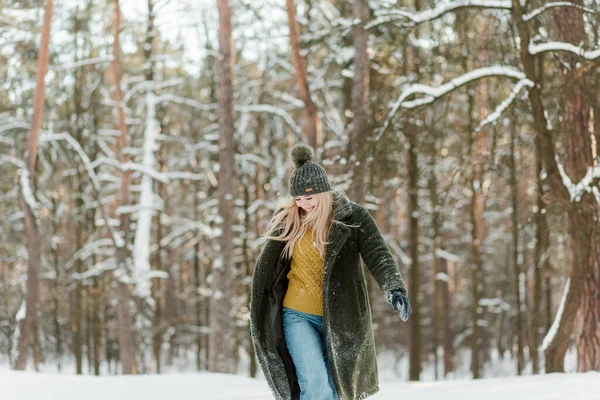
[358,207,406,299]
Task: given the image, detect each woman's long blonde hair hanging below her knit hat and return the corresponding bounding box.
[264,192,333,259]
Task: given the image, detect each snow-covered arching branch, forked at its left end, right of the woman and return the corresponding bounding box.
[377,65,526,140]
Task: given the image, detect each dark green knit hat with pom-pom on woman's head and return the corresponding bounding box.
[290,144,331,197]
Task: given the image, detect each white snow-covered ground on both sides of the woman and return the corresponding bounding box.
[0,370,600,400]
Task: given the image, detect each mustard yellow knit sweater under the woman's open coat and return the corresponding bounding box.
[283,228,325,315]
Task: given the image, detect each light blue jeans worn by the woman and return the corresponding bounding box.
[283,307,337,400]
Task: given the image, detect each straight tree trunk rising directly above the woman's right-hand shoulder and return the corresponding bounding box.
[350,0,370,205]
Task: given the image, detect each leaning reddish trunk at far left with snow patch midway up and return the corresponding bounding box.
[15,0,54,371]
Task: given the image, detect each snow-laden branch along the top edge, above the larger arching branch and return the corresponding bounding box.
[365,0,512,29]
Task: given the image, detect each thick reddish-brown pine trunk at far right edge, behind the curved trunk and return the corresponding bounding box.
[554,0,600,372]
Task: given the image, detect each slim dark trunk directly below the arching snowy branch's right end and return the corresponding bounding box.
[510,115,525,375]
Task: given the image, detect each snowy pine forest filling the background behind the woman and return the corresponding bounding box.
[0,0,600,387]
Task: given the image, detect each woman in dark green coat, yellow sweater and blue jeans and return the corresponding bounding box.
[251,145,410,400]
